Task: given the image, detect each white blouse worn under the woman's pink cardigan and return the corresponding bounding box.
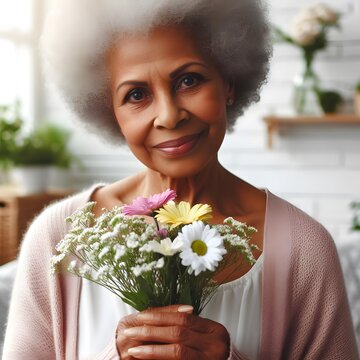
[78,255,263,360]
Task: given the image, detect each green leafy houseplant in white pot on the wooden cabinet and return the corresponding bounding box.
[0,104,80,193]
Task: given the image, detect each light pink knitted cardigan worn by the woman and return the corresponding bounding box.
[3,187,359,360]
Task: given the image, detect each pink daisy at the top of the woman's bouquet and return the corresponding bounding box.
[122,189,176,216]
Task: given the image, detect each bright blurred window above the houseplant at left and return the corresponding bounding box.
[0,0,42,124]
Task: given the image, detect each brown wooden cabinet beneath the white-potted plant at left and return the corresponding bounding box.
[0,186,69,265]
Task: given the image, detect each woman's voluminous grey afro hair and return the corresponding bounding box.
[40,0,271,143]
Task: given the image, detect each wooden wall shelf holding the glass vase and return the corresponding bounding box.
[264,114,360,149]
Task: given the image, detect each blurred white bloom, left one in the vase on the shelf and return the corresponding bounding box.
[290,18,321,46]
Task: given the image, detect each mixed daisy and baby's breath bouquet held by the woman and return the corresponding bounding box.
[51,189,257,314]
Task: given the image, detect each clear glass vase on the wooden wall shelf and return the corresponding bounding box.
[293,64,322,115]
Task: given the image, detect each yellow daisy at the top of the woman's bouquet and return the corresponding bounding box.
[155,201,212,229]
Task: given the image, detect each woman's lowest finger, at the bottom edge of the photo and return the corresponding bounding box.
[128,344,203,360]
